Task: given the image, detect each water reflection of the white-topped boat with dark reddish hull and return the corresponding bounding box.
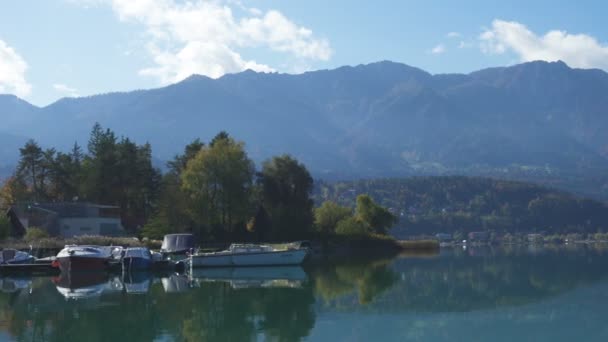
[53,272,123,299]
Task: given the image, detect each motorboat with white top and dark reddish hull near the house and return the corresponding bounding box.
[54,245,123,272]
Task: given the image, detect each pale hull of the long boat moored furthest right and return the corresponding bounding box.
[190,249,308,268]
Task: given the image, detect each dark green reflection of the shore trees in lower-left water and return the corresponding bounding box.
[0,278,315,341]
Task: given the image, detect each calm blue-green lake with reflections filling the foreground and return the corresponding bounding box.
[0,245,608,341]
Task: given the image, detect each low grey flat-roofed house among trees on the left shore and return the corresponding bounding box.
[13,202,125,238]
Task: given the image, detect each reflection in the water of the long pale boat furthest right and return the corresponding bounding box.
[190,266,308,288]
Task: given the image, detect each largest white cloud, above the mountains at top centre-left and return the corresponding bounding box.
[104,0,332,84]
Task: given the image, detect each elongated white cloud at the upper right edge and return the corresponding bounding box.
[479,20,608,70]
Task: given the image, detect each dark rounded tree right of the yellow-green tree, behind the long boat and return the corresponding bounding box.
[258,155,313,239]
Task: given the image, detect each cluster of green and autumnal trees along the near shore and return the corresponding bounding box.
[0,124,395,241]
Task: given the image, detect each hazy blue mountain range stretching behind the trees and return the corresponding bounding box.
[0,61,608,195]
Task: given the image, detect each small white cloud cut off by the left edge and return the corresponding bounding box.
[0,40,32,97]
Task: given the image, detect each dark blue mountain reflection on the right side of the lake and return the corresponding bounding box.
[330,248,608,312]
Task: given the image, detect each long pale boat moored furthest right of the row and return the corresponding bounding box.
[189,244,309,268]
